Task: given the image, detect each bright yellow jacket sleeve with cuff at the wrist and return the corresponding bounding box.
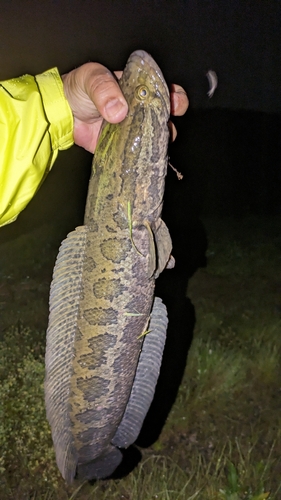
[0,68,73,226]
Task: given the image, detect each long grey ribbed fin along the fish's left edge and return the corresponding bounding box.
[45,226,88,483]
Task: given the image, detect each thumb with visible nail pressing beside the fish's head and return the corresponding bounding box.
[83,63,128,123]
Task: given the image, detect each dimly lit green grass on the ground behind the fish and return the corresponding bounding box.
[0,217,281,500]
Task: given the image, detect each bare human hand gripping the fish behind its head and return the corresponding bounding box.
[62,63,188,153]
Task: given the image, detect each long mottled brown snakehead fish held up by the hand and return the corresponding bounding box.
[45,51,173,483]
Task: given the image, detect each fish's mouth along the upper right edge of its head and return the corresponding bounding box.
[127,50,170,117]
